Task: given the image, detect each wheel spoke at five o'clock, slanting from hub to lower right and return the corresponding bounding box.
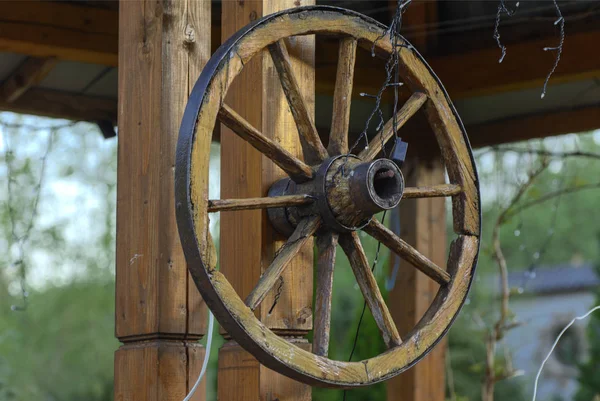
[340,231,402,348]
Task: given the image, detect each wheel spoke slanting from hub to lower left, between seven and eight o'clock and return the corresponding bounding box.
[246,216,321,310]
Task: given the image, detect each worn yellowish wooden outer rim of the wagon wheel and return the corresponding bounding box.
[175,6,480,387]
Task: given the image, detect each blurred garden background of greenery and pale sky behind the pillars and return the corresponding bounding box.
[0,108,600,401]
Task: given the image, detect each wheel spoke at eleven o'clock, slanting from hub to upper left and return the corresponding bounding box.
[269,40,329,164]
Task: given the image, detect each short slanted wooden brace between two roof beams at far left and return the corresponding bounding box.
[0,57,57,103]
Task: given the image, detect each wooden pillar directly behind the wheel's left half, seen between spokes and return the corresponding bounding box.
[218,0,314,401]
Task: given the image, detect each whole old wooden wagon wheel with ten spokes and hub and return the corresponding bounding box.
[175,6,480,387]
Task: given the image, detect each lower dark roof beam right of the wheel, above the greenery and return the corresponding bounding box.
[466,104,600,148]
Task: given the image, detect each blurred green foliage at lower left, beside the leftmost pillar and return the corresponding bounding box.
[0,280,118,401]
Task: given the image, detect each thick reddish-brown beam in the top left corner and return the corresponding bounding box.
[0,1,119,66]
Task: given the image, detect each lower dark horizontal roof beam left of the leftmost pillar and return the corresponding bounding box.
[0,88,117,125]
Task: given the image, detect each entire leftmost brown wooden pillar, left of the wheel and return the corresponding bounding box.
[115,0,210,401]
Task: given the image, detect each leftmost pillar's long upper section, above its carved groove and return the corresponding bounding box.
[116,0,210,338]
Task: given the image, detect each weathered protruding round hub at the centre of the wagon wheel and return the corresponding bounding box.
[268,155,404,236]
